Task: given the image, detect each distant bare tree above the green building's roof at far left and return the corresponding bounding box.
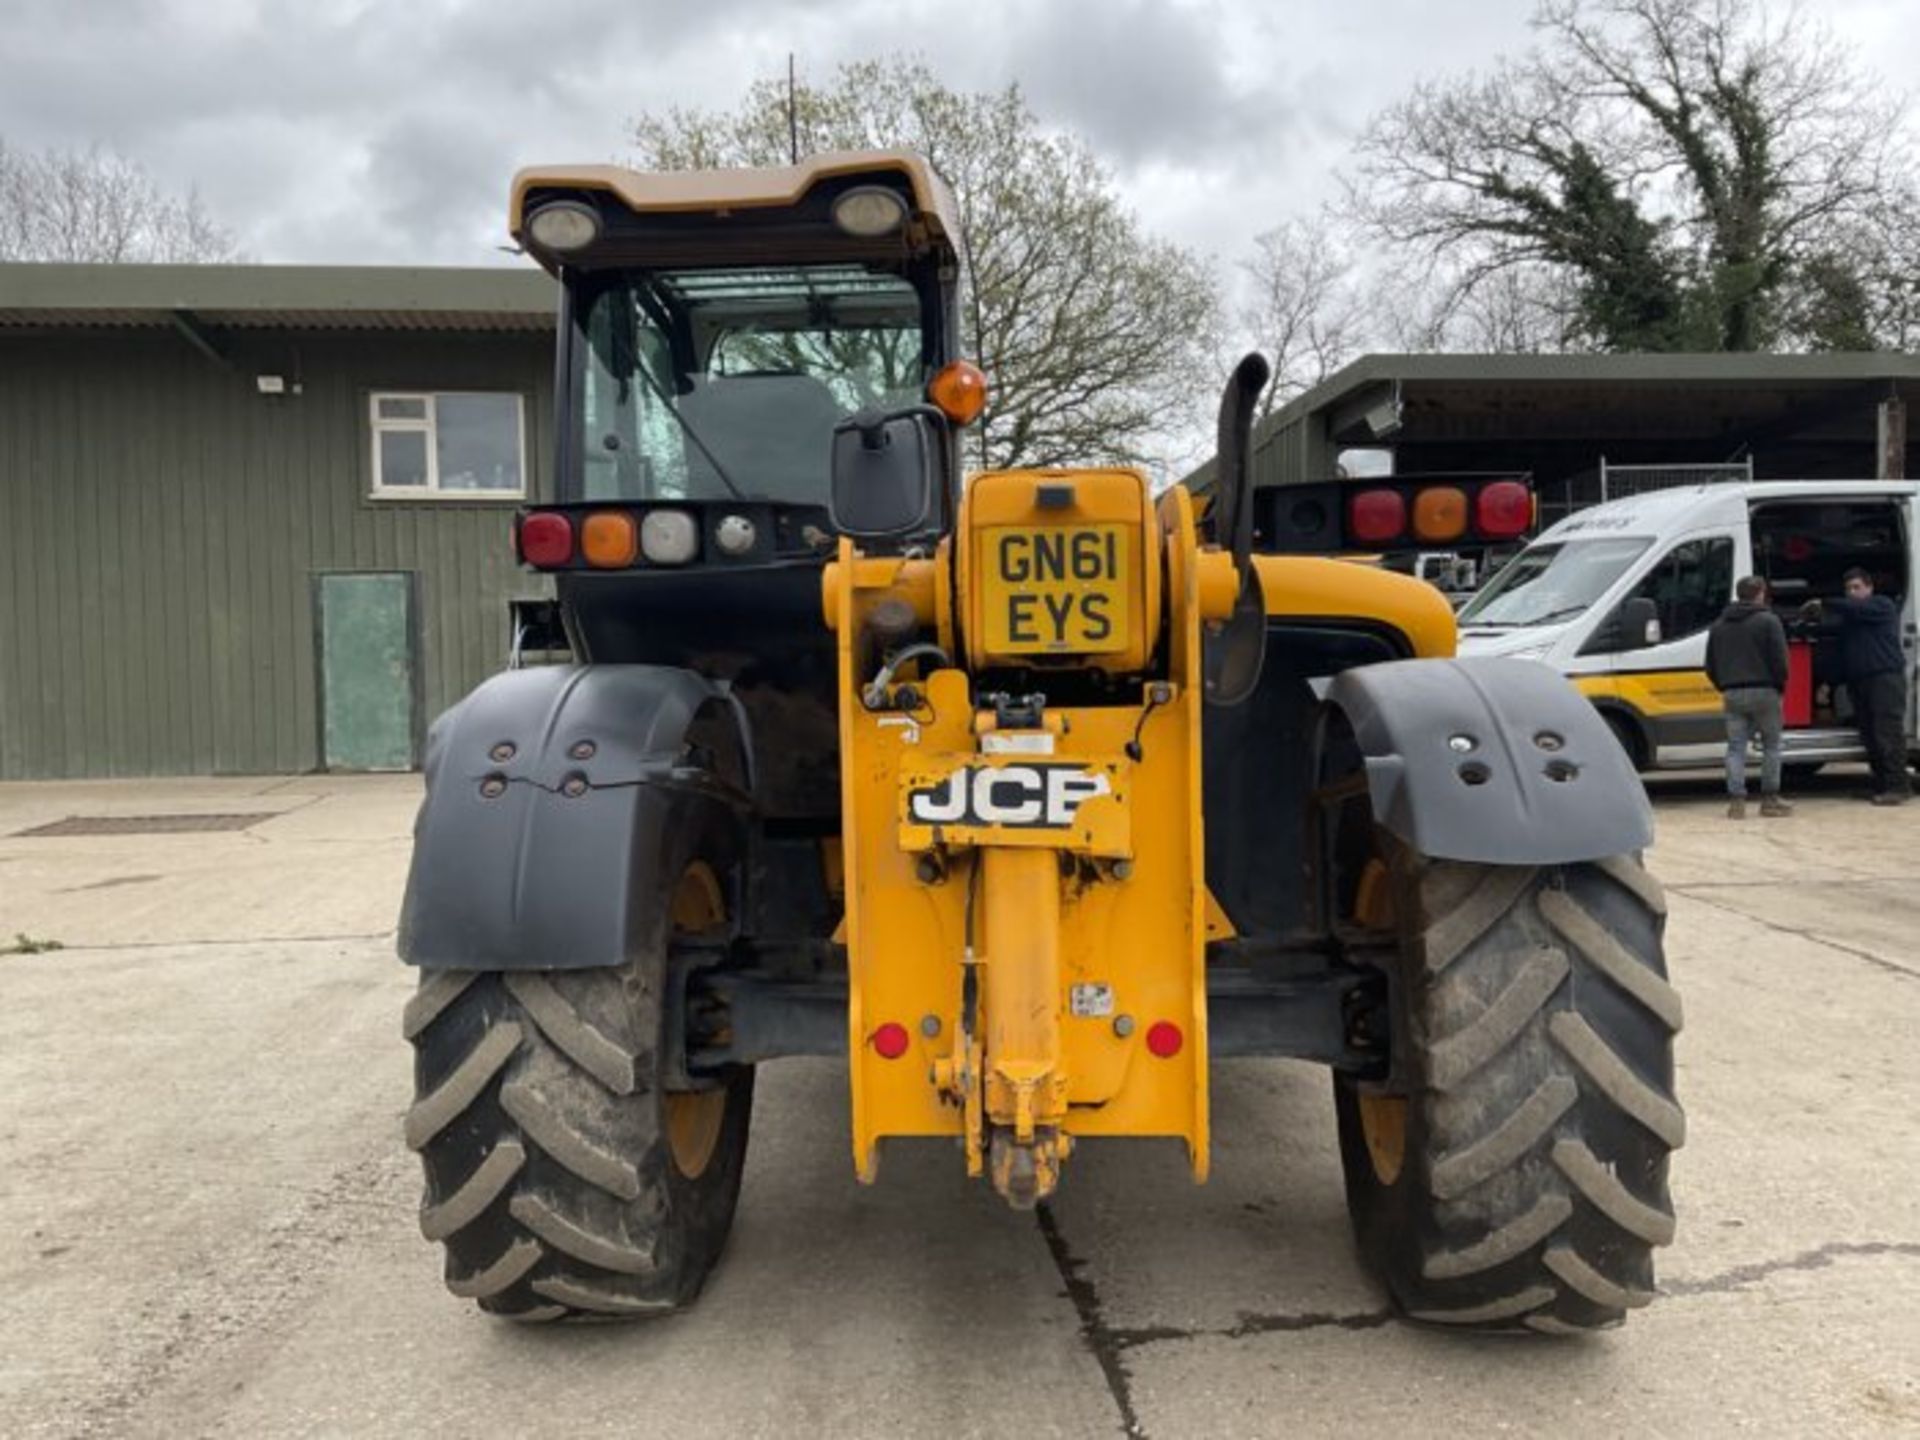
[0,140,244,265]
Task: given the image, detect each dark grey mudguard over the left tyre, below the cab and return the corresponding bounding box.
[399,664,751,970]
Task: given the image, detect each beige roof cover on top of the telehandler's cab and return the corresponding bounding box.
[507,150,960,248]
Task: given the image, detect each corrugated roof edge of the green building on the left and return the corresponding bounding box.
[0,265,557,330]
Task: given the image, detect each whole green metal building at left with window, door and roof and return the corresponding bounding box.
[0,265,555,780]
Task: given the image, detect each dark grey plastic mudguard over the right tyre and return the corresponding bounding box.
[1325,657,1653,864]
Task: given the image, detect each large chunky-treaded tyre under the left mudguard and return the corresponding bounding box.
[403,821,753,1321]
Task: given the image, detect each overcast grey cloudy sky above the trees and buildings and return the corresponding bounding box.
[0,0,1920,282]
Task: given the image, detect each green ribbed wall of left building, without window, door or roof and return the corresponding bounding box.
[0,330,553,780]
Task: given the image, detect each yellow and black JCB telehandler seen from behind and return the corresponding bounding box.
[399,152,1682,1331]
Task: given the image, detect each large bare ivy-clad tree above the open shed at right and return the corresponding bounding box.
[1348,0,1903,349]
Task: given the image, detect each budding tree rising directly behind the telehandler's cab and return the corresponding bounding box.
[634,60,1217,474]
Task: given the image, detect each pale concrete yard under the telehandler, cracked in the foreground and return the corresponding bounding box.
[0,770,1920,1440]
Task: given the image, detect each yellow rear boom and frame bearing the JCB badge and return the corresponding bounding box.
[826,470,1235,1202]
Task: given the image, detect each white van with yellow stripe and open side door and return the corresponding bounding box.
[1459,480,1920,770]
